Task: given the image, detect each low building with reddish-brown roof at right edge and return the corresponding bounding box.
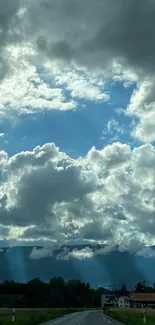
[130,292,155,308]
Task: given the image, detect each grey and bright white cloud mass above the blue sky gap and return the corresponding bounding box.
[0,0,155,143]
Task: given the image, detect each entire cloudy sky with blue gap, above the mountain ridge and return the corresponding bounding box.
[0,0,155,259]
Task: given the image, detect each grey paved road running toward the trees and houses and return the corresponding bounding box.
[42,311,122,325]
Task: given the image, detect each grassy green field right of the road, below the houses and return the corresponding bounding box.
[104,308,155,325]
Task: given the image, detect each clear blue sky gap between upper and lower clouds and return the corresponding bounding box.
[0,82,135,157]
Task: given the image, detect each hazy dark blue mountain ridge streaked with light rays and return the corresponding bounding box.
[0,246,155,288]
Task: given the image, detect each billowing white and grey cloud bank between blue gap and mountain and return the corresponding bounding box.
[0,142,155,257]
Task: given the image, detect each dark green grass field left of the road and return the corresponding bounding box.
[0,308,85,325]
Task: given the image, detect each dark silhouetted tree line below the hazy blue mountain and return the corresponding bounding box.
[0,277,155,308]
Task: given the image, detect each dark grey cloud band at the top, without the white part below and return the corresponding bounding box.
[0,0,155,77]
